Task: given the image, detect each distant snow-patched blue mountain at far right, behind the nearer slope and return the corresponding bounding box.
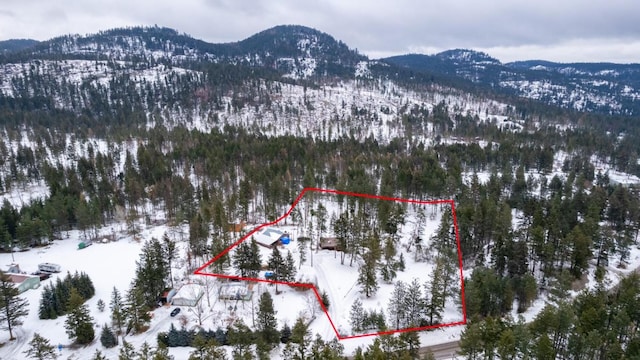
[384,50,640,115]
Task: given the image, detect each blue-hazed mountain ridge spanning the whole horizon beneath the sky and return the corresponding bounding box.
[0,25,640,116]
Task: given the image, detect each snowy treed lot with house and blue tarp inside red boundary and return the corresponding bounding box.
[195,188,466,340]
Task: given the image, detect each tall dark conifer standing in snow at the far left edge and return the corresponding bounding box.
[0,272,29,340]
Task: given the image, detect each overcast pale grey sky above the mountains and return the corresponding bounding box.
[0,0,640,63]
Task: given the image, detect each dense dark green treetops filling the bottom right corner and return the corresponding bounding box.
[460,274,640,359]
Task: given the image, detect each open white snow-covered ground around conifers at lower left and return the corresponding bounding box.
[0,217,201,360]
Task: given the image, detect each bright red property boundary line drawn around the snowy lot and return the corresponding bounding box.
[194,188,467,340]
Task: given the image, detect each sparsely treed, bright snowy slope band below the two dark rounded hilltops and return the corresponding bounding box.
[0,52,512,143]
